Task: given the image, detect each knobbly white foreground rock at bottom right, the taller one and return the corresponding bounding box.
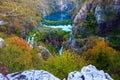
[67,65,113,80]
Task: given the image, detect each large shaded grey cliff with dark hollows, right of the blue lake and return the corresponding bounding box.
[70,0,120,54]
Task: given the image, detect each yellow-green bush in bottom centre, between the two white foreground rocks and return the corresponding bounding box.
[43,51,86,79]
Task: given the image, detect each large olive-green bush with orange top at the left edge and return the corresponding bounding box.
[0,37,33,72]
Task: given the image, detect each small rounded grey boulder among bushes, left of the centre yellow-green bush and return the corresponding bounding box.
[38,46,52,60]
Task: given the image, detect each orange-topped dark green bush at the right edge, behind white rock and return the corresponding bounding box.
[82,40,120,77]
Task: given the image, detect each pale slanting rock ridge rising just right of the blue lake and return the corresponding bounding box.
[72,0,93,35]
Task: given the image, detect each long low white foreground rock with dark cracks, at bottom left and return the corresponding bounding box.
[6,70,60,80]
